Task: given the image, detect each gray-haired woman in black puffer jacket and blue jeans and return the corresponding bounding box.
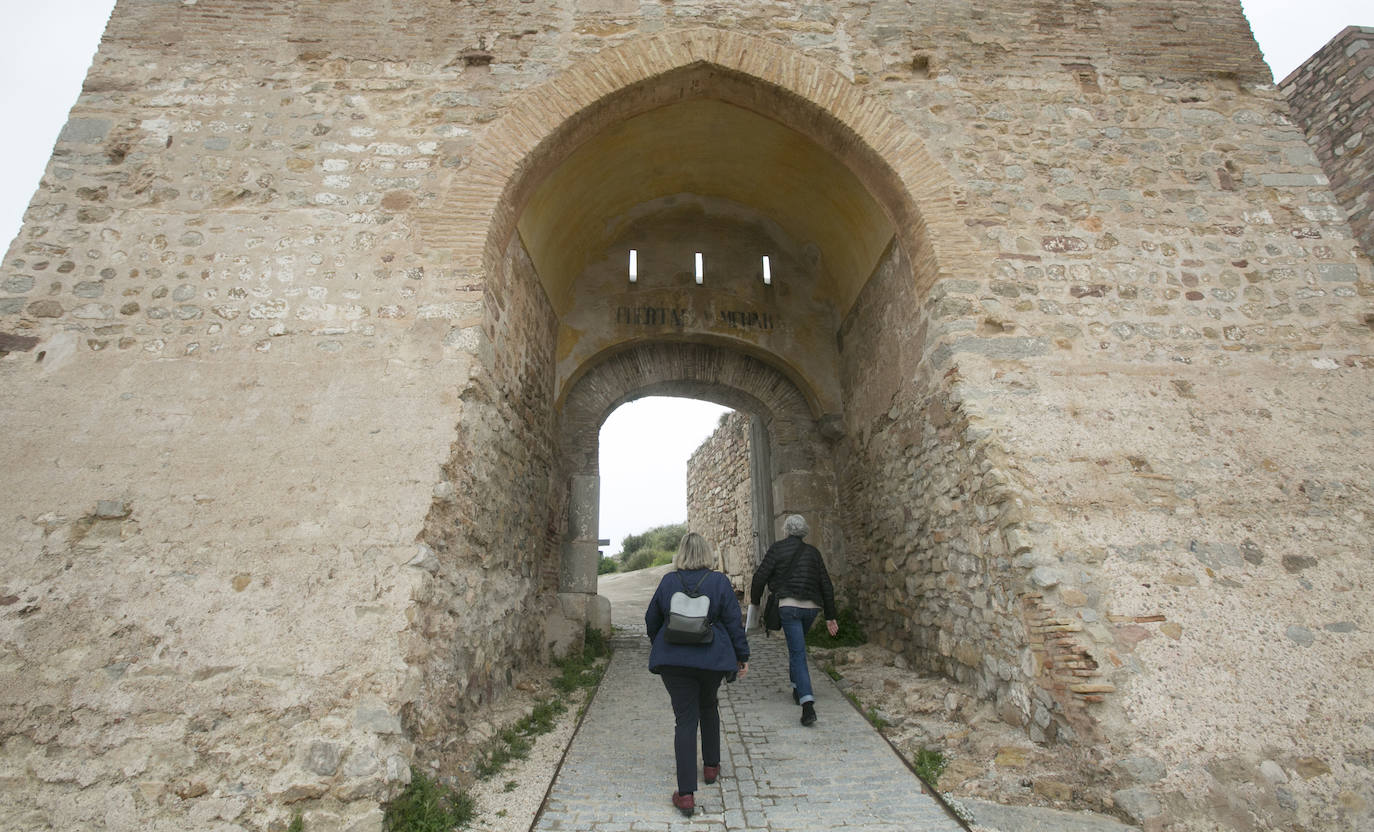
[749,515,840,726]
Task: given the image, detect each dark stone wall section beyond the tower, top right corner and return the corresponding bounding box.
[1281,26,1374,260]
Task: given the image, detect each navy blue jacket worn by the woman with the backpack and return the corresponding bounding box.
[644,570,749,673]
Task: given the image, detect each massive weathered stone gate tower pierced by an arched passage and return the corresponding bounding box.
[0,0,1374,829]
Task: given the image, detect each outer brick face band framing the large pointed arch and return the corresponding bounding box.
[419,27,971,291]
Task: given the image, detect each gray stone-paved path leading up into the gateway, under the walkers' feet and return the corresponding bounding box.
[533,633,962,832]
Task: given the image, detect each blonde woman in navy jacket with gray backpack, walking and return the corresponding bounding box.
[644,531,749,817]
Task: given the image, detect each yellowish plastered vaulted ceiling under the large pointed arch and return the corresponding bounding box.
[518,99,893,316]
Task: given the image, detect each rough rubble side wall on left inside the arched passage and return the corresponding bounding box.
[404,232,566,772]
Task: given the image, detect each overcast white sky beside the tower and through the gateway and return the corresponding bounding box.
[0,0,1374,553]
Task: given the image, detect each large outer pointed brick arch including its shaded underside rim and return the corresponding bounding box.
[418,27,974,302]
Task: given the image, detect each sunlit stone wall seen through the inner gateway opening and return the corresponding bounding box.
[687,411,758,592]
